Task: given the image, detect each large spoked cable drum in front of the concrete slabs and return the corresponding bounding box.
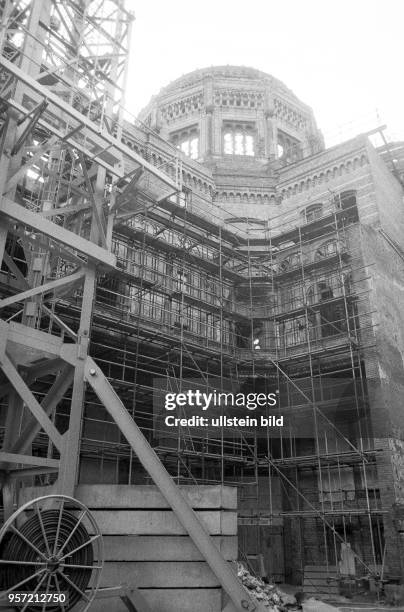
[0,495,103,612]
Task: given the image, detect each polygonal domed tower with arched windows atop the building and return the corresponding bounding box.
[139,66,324,167]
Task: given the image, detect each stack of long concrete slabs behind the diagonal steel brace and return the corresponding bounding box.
[76,485,237,612]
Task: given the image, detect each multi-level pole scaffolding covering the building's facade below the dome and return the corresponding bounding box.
[0,166,383,569]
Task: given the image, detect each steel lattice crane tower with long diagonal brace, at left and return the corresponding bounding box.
[0,0,272,612]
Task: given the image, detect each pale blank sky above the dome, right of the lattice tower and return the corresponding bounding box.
[125,0,404,144]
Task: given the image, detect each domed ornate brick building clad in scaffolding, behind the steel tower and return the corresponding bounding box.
[74,66,404,584]
